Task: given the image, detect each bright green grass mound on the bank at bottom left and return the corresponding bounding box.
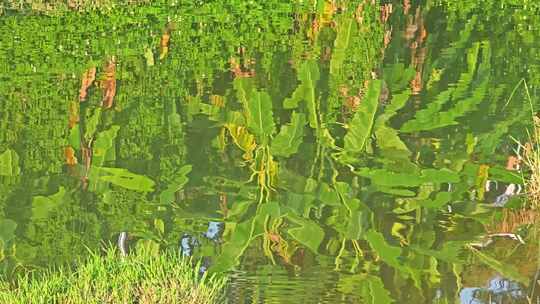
[0,249,225,304]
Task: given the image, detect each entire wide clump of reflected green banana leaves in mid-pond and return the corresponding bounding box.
[197,44,502,300]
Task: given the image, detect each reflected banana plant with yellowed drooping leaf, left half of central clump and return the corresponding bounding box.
[205,61,378,270]
